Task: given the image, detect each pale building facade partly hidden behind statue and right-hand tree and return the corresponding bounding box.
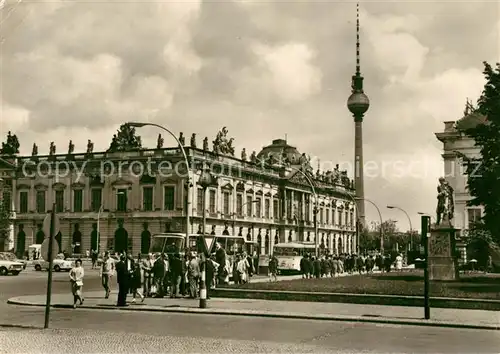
[436,103,486,261]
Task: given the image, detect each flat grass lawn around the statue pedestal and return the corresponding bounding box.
[230,272,500,300]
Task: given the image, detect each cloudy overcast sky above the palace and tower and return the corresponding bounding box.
[0,0,500,229]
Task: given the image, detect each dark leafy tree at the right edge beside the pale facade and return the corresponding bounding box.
[462,62,500,243]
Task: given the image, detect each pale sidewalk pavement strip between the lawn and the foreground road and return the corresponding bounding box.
[8,291,500,330]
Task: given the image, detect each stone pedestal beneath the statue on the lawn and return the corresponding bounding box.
[427,223,457,280]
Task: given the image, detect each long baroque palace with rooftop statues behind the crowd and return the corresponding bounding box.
[0,128,357,255]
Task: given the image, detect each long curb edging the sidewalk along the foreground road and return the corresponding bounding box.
[7,299,500,331]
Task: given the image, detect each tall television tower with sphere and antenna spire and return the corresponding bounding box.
[347,3,370,226]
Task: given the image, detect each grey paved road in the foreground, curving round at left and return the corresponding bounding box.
[0,271,500,353]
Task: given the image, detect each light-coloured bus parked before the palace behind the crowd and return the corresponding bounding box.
[273,242,315,274]
